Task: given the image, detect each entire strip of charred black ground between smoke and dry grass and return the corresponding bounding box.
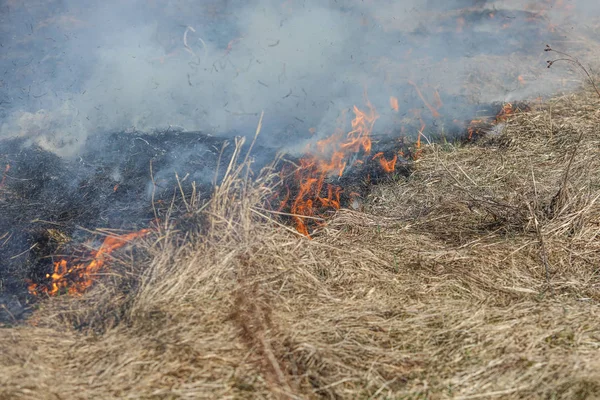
[0,98,524,320]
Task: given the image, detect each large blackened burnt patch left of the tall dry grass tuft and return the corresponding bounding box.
[0,132,260,317]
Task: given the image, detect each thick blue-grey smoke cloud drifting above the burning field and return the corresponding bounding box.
[0,0,600,156]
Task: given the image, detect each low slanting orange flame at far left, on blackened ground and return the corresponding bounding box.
[29,229,150,296]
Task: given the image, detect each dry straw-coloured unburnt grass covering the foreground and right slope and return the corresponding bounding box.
[0,89,600,399]
